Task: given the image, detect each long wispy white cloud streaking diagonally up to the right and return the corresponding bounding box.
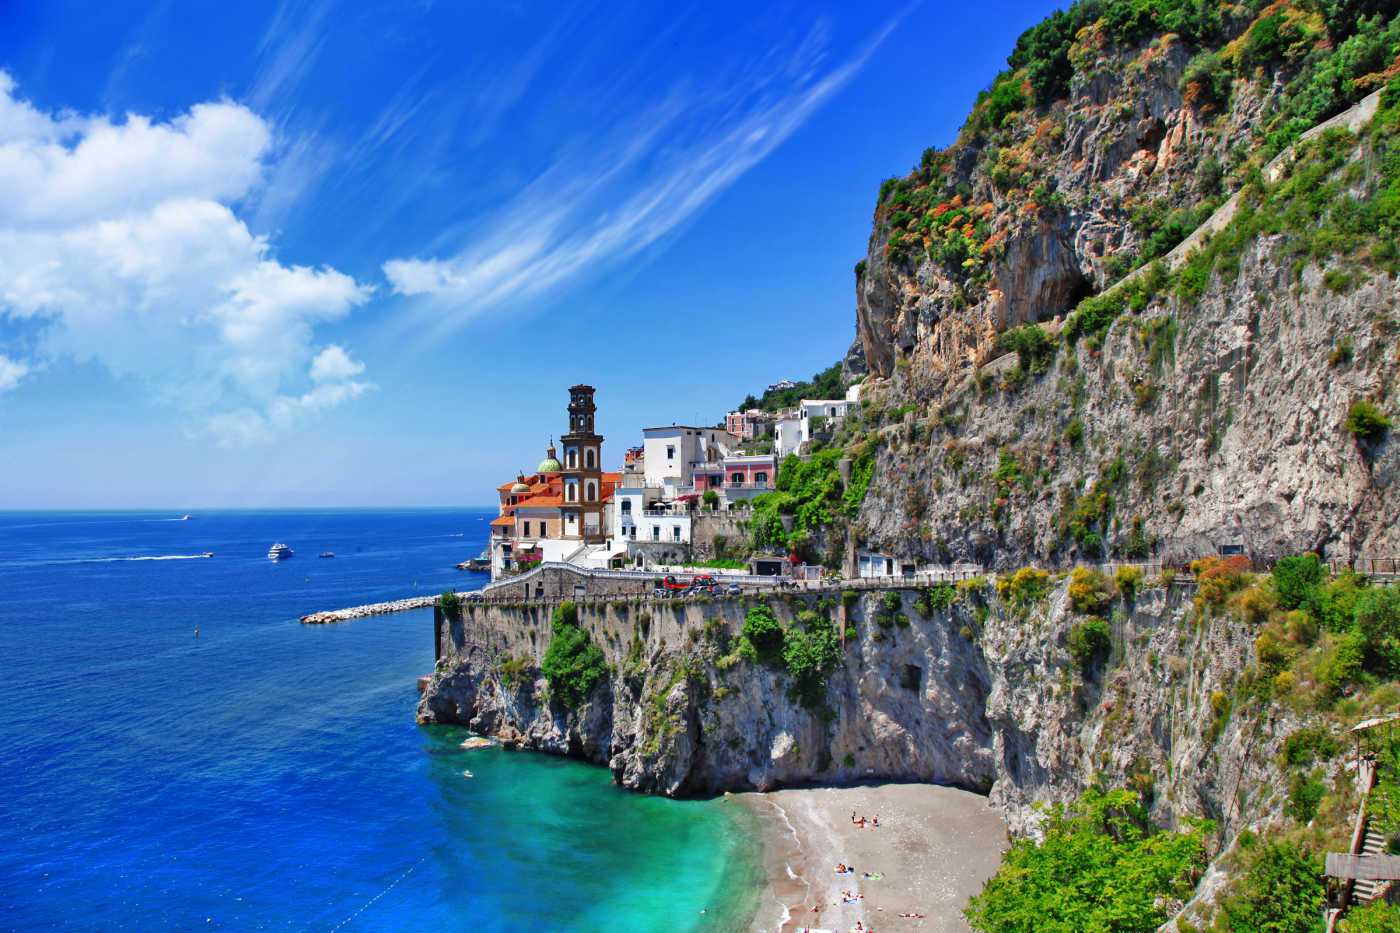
[384,15,900,331]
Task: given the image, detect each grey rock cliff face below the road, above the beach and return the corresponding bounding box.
[419,584,1296,834]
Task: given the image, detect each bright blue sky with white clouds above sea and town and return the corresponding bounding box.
[0,0,1054,509]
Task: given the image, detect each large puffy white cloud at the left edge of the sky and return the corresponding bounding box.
[0,71,371,440]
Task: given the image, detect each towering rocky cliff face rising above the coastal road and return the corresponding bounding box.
[855,12,1400,567]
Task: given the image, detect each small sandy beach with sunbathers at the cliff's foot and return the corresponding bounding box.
[738,785,1007,933]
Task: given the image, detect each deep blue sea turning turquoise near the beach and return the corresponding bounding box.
[0,510,759,932]
